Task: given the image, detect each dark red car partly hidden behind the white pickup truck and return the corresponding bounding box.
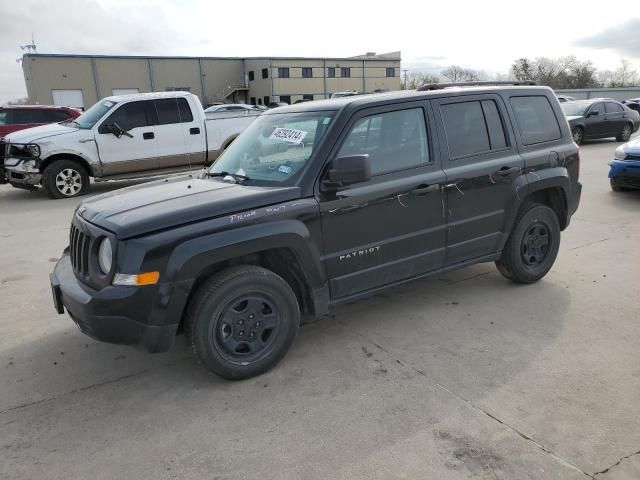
[0,105,82,184]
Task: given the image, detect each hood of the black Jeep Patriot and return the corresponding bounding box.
[78,177,300,239]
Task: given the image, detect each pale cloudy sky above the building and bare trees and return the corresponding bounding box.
[0,0,640,103]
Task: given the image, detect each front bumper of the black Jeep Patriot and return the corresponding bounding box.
[50,252,191,352]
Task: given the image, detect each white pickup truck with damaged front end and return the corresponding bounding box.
[0,92,261,198]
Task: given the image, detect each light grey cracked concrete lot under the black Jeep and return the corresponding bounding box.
[0,137,640,480]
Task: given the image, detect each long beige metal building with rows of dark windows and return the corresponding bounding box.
[22,52,400,108]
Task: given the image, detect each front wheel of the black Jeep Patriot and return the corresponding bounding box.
[185,266,300,380]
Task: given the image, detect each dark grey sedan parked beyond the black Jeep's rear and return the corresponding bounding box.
[561,98,640,145]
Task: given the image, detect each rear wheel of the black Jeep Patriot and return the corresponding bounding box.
[496,203,560,283]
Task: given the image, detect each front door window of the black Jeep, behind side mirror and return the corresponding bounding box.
[338,108,429,175]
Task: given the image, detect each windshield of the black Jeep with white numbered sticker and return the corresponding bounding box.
[209,112,335,185]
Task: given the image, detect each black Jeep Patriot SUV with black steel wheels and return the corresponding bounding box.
[51,84,581,379]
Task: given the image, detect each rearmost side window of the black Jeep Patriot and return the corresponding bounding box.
[509,95,562,145]
